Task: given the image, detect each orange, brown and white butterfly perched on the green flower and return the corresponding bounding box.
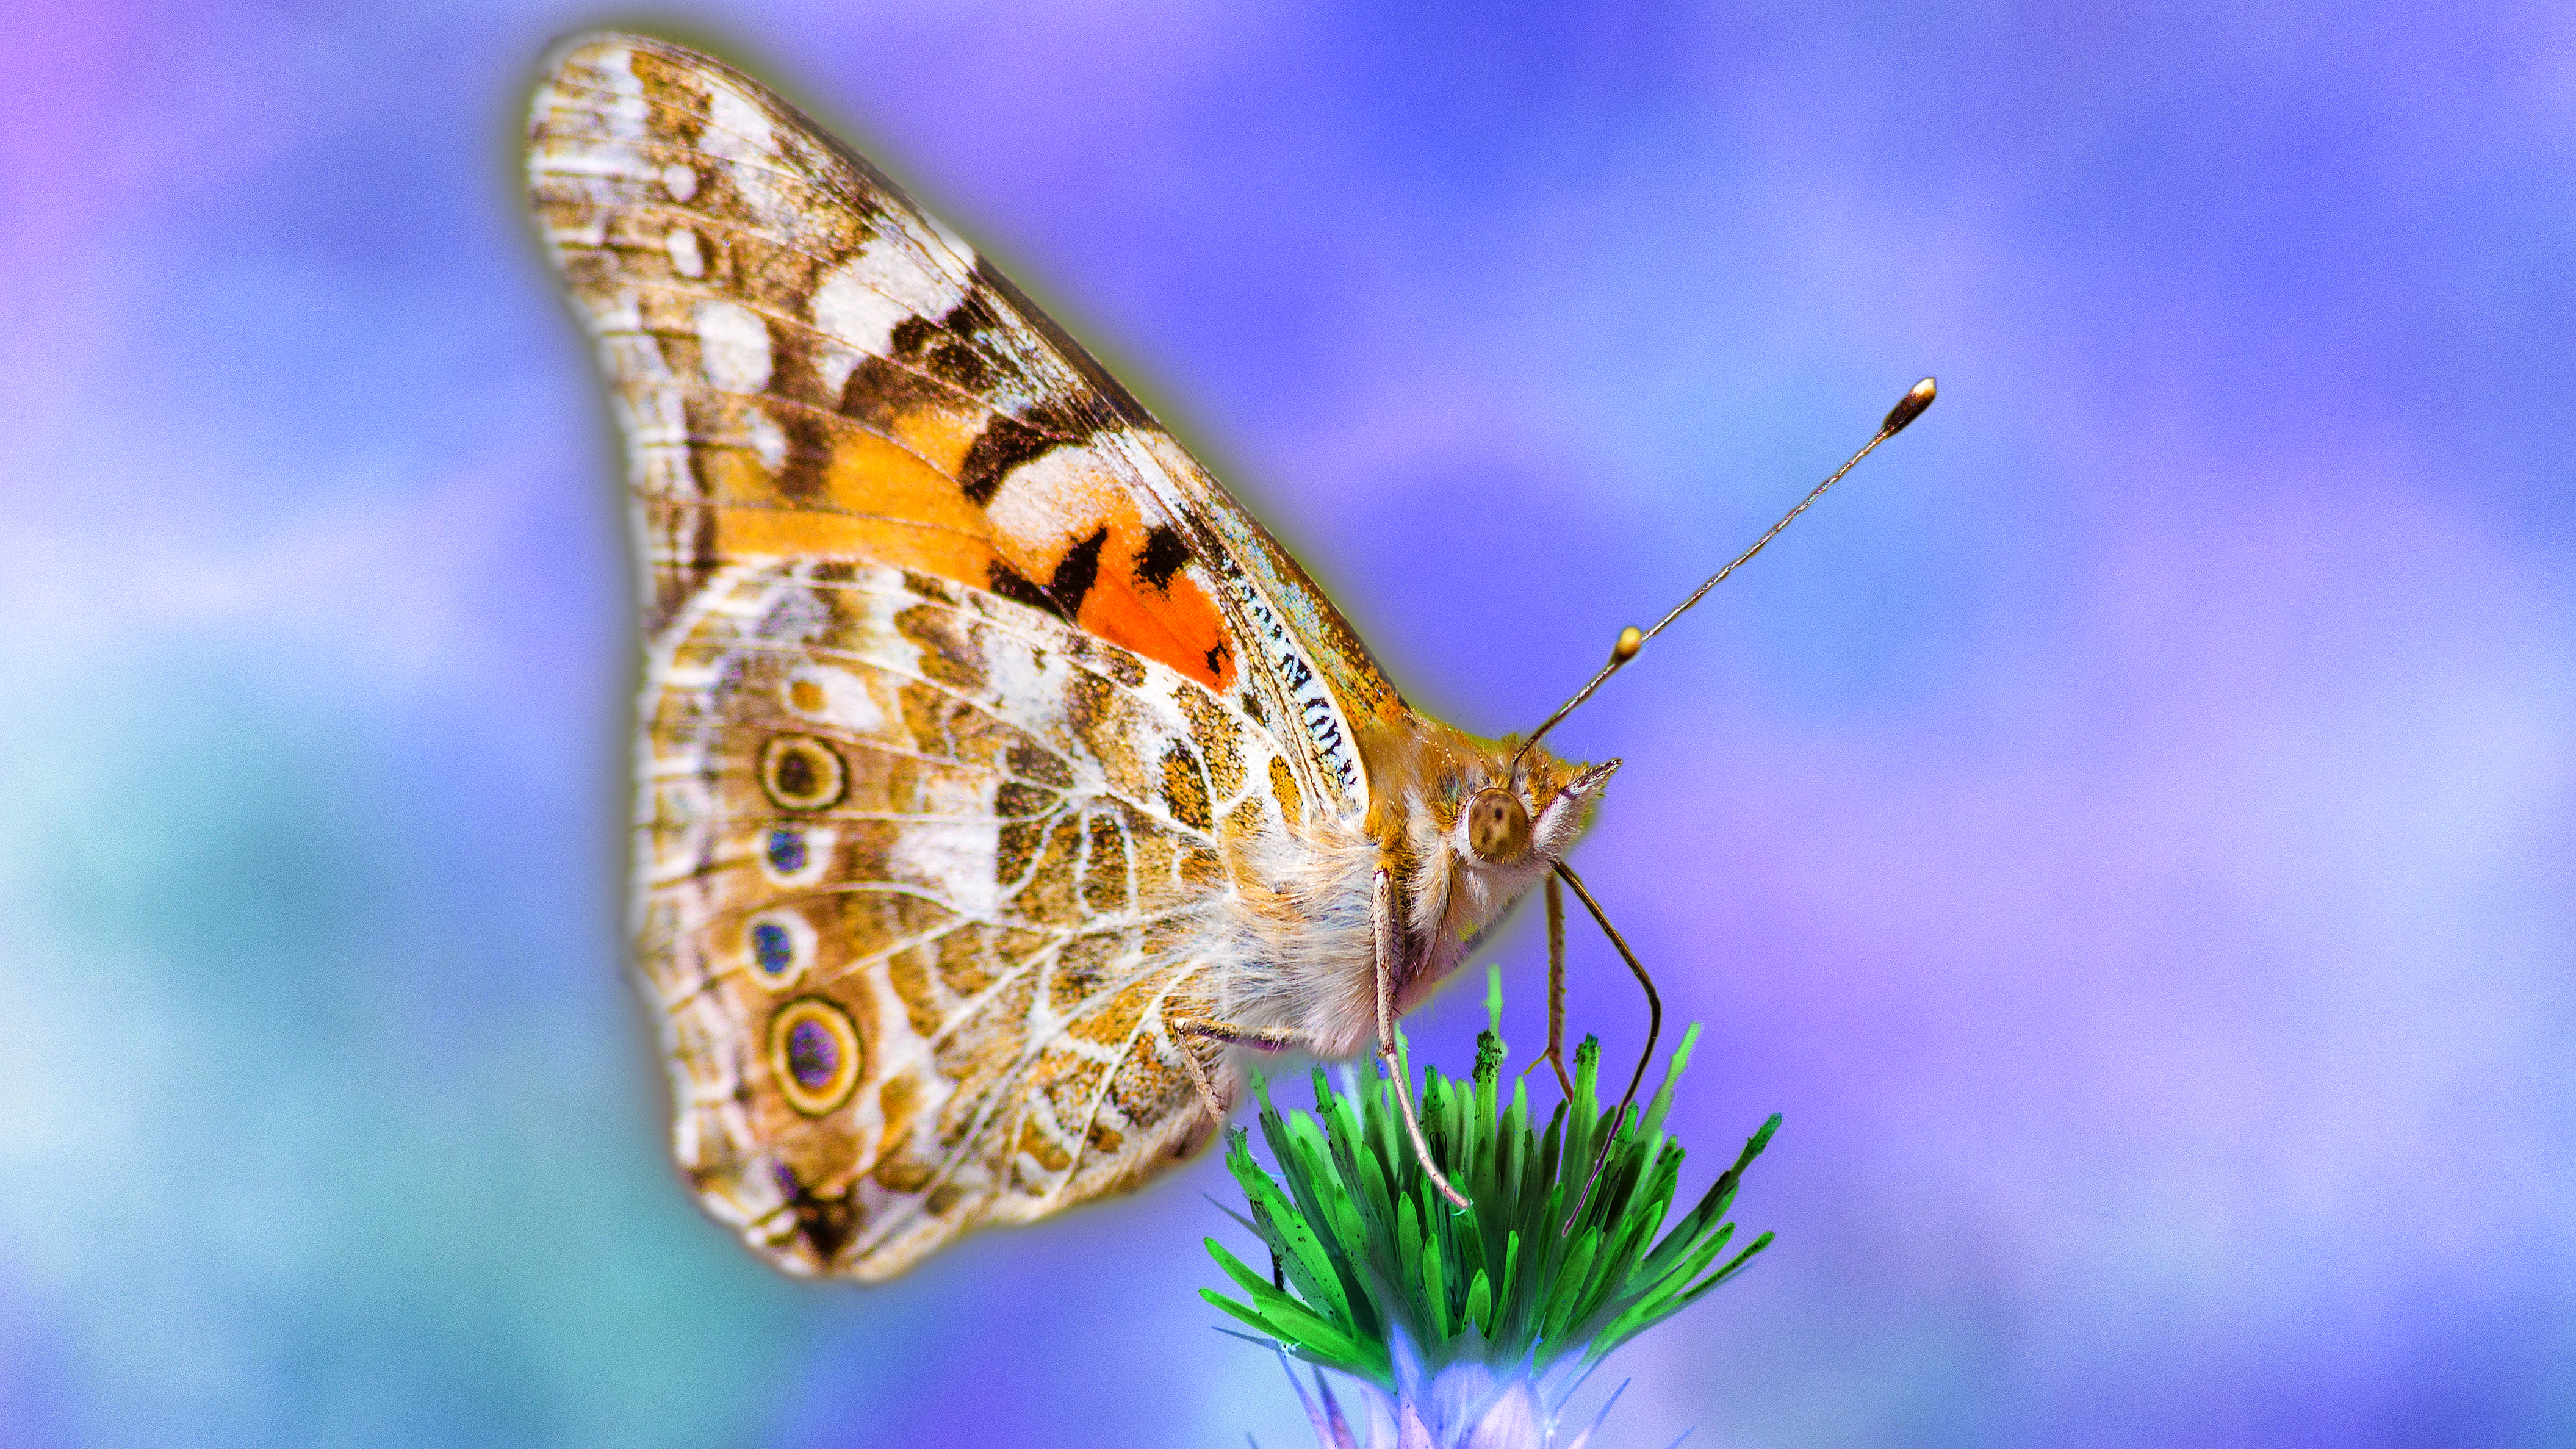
[528,34,1937,1282]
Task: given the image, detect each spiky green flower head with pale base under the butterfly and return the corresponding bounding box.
[1200,973,1780,1449]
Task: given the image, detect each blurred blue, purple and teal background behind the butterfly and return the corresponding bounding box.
[0,0,2576,1449]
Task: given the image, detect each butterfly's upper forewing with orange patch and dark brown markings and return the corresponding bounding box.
[528,36,1401,811]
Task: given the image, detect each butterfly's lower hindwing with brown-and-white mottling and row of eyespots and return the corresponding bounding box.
[636,564,1301,1279]
